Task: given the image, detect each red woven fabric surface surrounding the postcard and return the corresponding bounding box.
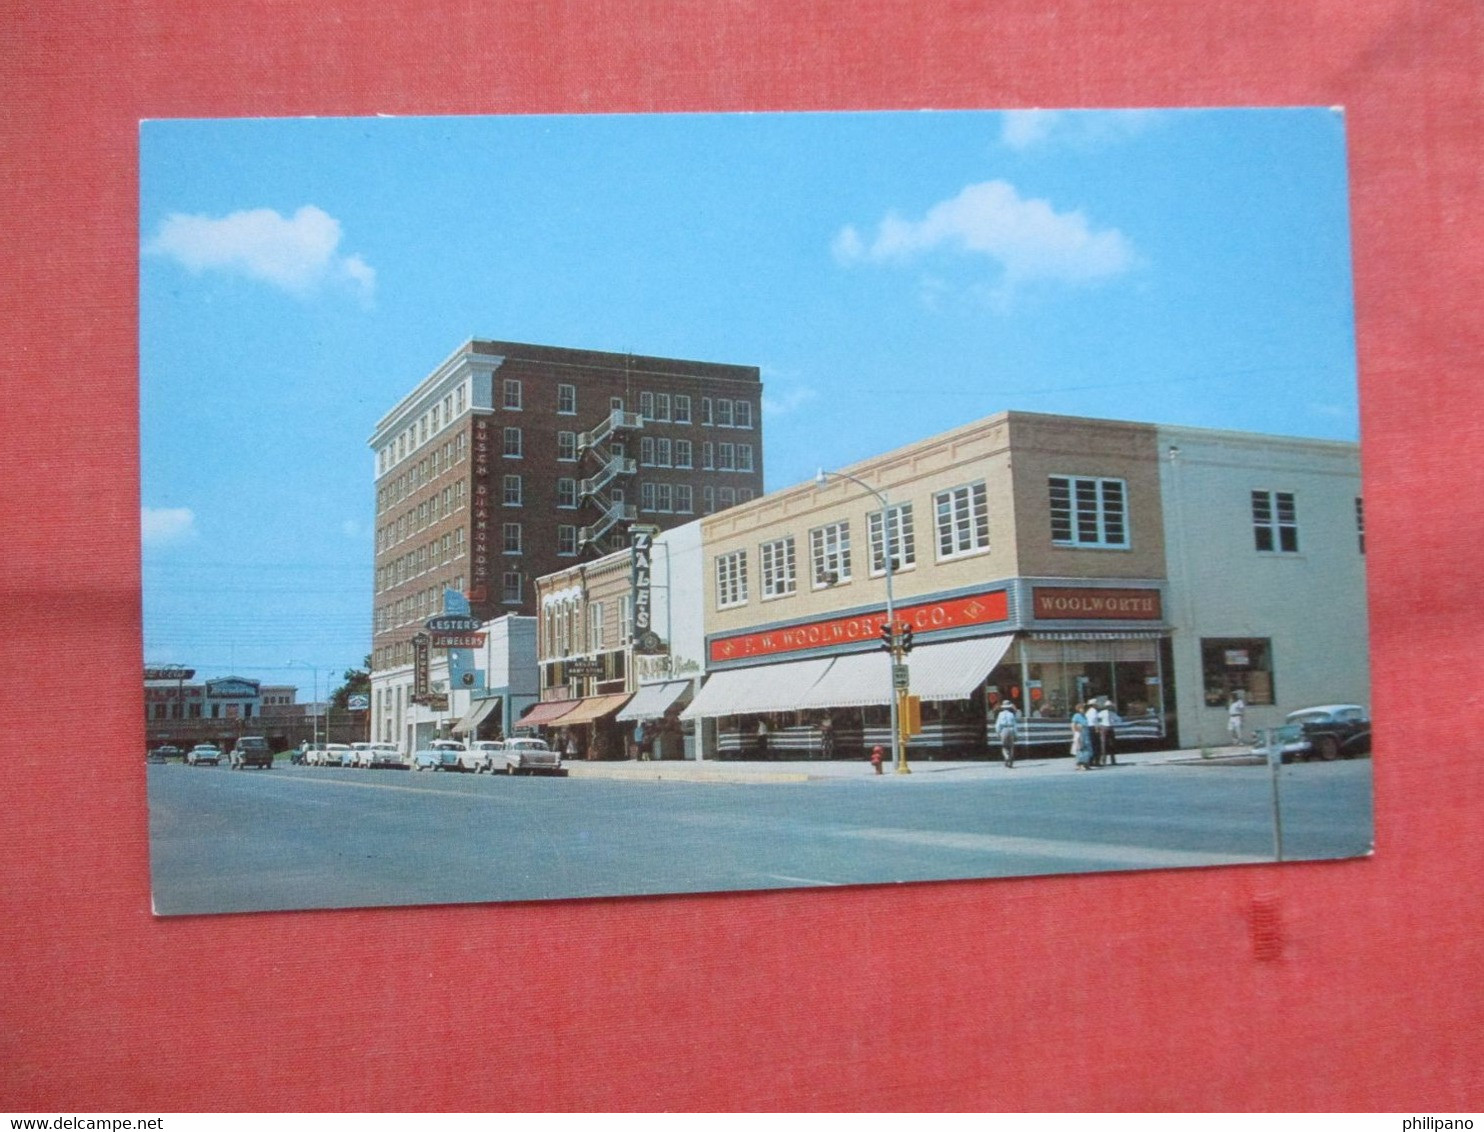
[0,0,1484,1111]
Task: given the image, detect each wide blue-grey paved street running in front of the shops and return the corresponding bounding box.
[148,752,1371,915]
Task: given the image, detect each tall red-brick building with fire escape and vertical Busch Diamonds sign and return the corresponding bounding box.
[370,340,763,753]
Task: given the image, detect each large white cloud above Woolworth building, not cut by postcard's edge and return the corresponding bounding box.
[834,181,1135,286]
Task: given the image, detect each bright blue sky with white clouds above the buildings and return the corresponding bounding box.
[139,108,1358,697]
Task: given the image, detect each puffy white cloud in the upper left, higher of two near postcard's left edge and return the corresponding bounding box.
[144,205,375,301]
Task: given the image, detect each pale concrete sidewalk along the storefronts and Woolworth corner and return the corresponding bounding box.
[564,746,1260,783]
